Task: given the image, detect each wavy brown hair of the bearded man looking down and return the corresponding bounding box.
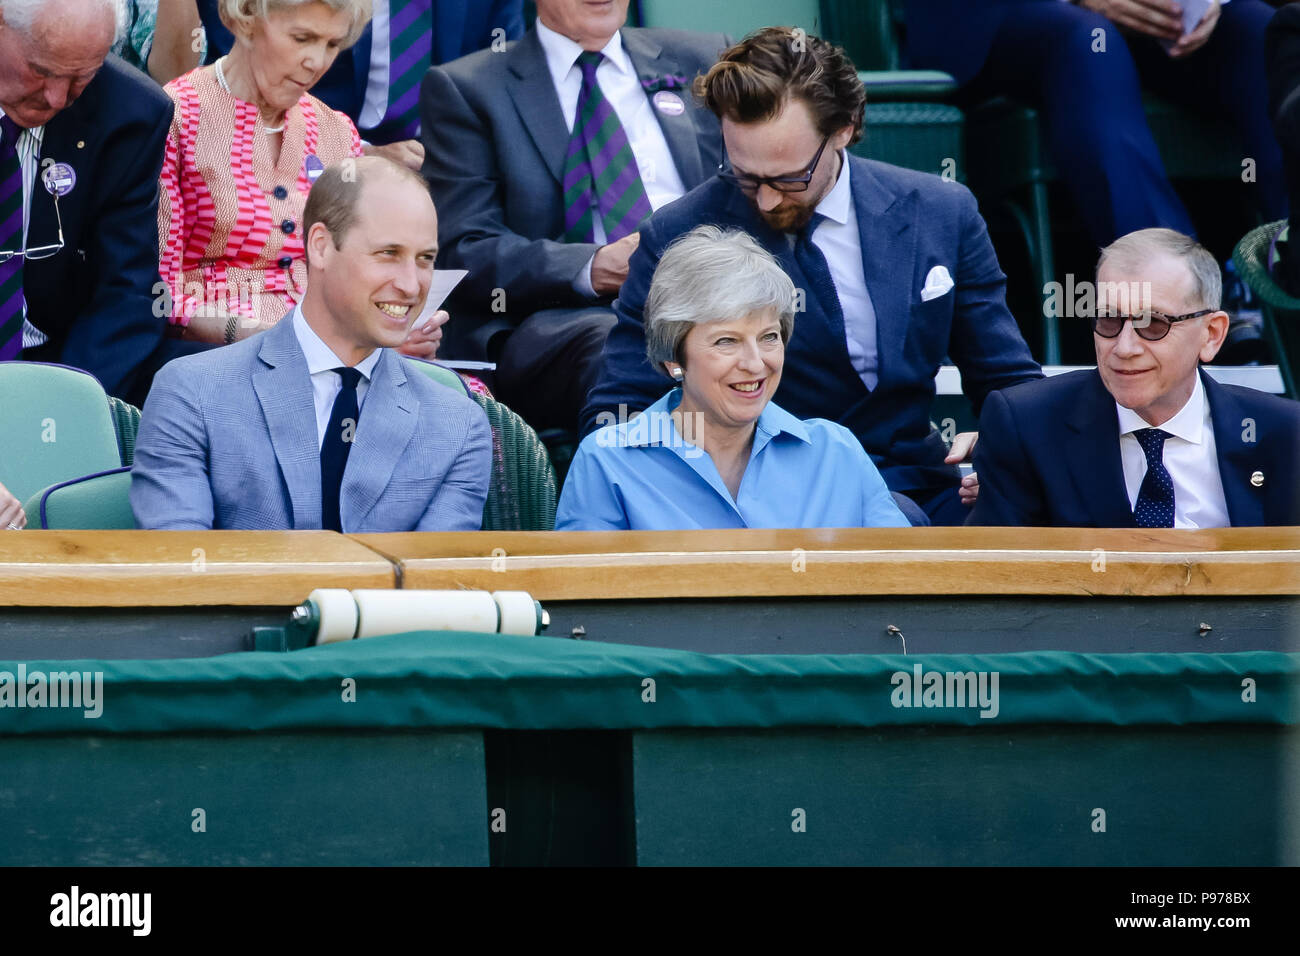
[694,26,867,143]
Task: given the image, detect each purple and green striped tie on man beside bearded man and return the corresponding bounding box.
[563,52,651,242]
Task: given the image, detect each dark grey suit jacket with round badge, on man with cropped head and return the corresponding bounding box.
[420,27,731,358]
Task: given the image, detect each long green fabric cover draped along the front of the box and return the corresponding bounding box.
[0,632,1300,735]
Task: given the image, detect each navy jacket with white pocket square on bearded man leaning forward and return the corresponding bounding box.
[582,156,1041,498]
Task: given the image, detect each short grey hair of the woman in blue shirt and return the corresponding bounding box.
[645,226,794,372]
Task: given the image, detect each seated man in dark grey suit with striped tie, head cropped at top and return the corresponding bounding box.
[420,0,729,429]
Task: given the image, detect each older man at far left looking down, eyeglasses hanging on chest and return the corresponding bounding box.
[0,0,172,403]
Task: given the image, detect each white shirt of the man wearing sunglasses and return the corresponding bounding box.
[1115,375,1230,528]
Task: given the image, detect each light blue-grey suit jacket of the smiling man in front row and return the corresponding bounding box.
[131,316,491,532]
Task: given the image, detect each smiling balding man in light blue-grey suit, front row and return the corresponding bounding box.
[131,157,491,532]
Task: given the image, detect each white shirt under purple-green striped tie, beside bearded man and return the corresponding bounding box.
[536,20,686,298]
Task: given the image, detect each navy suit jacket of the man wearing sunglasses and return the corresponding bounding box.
[966,369,1300,528]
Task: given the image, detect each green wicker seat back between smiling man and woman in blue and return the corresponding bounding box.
[408,360,556,531]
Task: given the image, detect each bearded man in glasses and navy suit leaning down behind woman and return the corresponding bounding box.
[582,27,1041,524]
